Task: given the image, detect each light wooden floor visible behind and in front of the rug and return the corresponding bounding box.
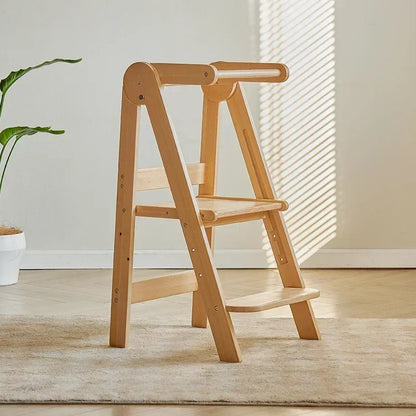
[0,270,416,416]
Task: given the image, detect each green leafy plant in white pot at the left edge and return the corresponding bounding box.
[0,58,81,286]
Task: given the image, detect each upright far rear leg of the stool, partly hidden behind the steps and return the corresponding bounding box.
[192,92,220,328]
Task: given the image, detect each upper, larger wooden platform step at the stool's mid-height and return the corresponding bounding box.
[136,195,288,227]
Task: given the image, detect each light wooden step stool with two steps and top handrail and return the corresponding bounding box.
[110,62,320,362]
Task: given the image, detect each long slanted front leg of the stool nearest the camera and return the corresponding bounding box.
[138,64,241,362]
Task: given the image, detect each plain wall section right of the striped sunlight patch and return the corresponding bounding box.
[329,0,416,248]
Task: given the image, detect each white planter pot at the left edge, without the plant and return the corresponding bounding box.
[0,232,26,286]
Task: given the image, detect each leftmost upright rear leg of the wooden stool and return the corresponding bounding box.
[110,87,140,348]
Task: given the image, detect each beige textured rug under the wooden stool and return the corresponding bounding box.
[0,315,416,407]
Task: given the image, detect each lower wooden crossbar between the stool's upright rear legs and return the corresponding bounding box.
[131,270,198,303]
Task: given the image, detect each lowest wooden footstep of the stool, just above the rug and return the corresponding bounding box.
[225,287,320,312]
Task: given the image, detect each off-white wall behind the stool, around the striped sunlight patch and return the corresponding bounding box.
[0,0,416,267]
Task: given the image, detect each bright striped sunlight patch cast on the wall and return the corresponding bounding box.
[260,0,336,265]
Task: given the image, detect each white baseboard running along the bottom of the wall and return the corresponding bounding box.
[22,249,416,269]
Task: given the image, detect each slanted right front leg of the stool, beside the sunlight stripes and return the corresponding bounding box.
[227,83,320,339]
